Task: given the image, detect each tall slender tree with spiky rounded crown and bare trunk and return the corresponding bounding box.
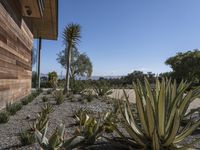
[63,23,81,94]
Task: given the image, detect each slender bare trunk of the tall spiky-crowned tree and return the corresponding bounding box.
[63,45,72,94]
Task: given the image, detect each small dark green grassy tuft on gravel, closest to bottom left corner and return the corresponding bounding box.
[19,130,36,146]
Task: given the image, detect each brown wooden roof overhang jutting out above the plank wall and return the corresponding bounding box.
[20,0,58,40]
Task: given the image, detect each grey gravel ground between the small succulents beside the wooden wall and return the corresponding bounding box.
[0,92,200,150]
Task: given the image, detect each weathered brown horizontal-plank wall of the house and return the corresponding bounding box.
[0,1,33,108]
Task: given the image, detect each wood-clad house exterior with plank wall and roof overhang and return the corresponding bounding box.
[0,0,58,108]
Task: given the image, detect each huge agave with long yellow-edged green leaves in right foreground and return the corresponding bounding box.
[115,79,200,150]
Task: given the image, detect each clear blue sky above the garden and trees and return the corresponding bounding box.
[38,0,200,75]
